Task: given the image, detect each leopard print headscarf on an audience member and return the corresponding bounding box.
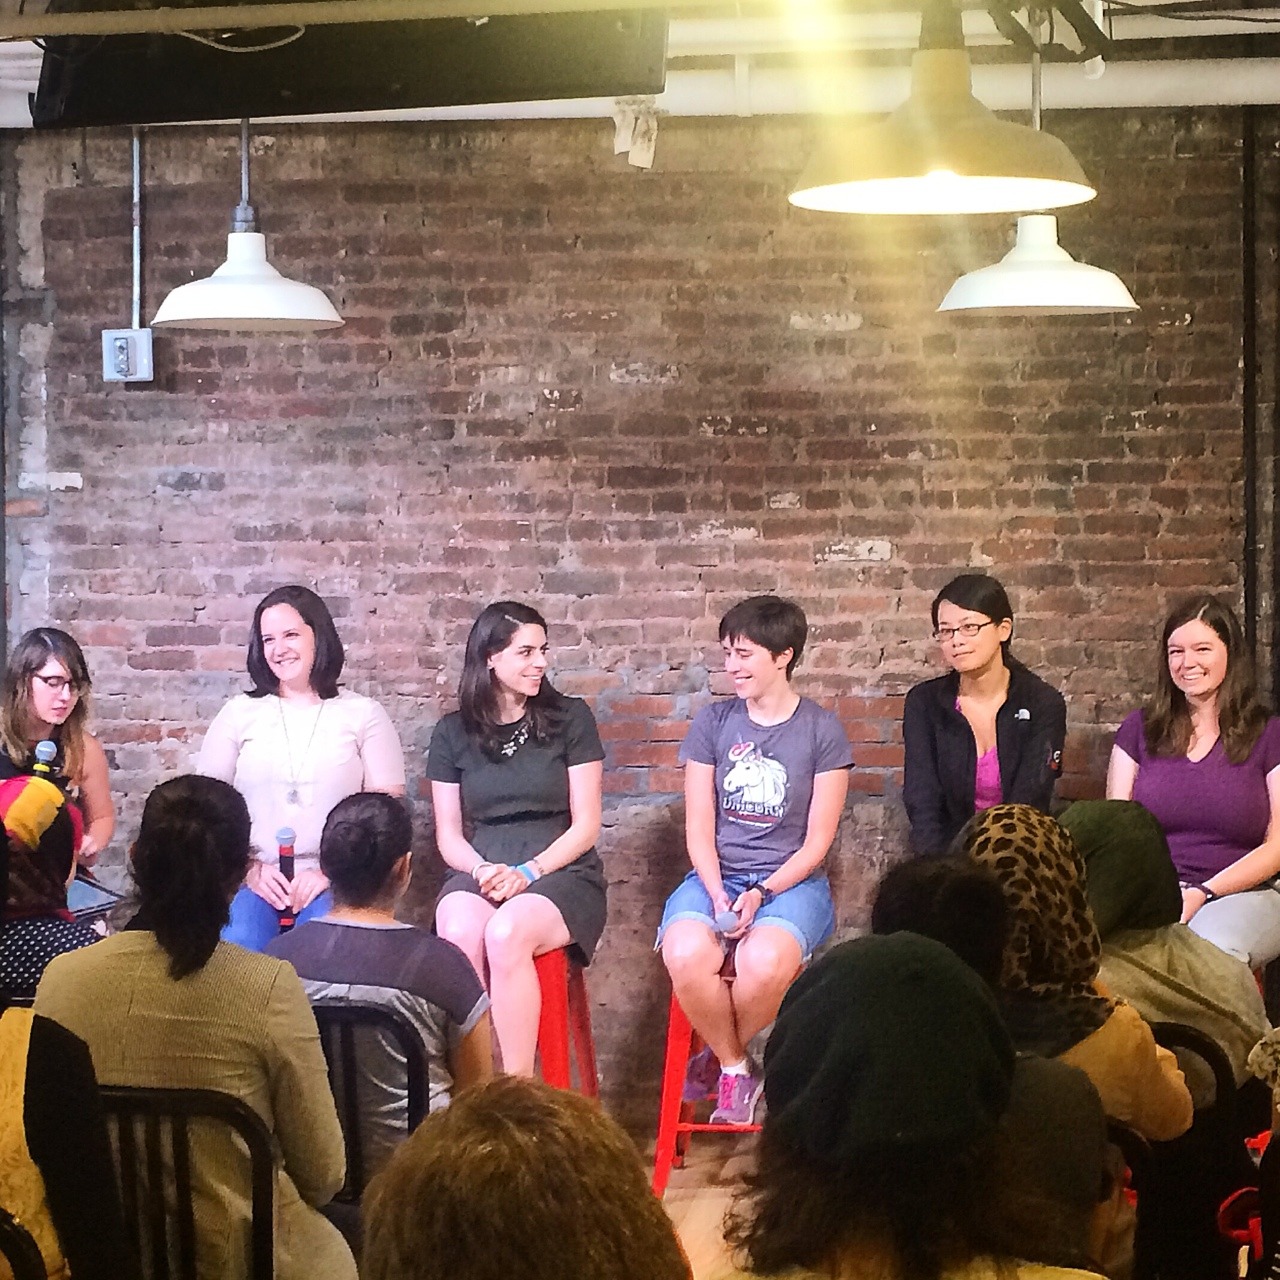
[956,804,1114,1053]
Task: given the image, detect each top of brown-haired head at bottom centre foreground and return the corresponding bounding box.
[360,1075,690,1280]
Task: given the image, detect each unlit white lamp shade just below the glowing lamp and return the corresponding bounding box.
[938,214,1138,316]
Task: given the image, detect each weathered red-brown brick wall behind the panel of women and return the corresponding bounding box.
[0,111,1280,1128]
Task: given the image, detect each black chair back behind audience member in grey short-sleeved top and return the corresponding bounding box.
[311,1002,426,1204]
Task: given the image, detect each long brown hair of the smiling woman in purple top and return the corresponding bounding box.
[1142,594,1268,764]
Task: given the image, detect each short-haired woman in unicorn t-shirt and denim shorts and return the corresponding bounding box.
[658,595,852,1124]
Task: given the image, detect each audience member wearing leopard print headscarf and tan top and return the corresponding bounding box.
[957,804,1192,1139]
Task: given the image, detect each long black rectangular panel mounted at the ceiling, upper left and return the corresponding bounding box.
[32,0,667,128]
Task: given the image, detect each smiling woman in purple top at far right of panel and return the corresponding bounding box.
[1107,595,1280,968]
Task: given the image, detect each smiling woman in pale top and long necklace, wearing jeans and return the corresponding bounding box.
[196,586,404,951]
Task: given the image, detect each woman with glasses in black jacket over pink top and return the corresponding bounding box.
[902,573,1066,854]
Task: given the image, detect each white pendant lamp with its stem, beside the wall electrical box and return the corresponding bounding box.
[151,120,343,333]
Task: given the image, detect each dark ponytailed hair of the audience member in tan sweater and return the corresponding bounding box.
[133,774,250,979]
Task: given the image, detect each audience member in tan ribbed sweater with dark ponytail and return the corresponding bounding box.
[36,776,356,1280]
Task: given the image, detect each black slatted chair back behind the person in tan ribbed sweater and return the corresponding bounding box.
[101,1085,275,1280]
